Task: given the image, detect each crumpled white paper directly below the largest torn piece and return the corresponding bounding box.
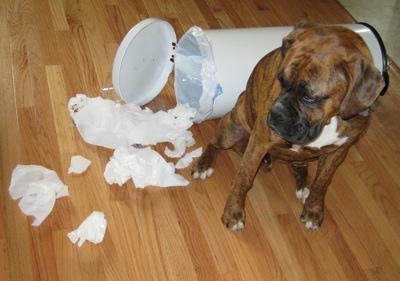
[104,145,189,188]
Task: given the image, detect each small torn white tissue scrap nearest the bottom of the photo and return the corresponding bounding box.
[67,211,107,247]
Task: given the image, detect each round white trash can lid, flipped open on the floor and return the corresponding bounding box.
[112,18,176,105]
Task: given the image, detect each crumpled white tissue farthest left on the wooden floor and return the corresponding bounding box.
[9,165,69,226]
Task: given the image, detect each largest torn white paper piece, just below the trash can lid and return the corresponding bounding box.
[68,94,196,157]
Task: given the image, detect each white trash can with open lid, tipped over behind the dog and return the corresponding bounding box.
[112,18,389,123]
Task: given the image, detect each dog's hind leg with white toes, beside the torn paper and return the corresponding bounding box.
[192,112,248,180]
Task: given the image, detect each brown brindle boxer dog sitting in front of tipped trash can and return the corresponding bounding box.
[192,21,384,231]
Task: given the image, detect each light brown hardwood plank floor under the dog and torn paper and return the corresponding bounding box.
[0,0,400,281]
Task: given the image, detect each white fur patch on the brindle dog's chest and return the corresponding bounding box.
[290,116,348,151]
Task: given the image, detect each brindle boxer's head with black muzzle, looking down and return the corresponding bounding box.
[268,21,384,145]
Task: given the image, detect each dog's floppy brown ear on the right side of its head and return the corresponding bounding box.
[340,56,385,120]
